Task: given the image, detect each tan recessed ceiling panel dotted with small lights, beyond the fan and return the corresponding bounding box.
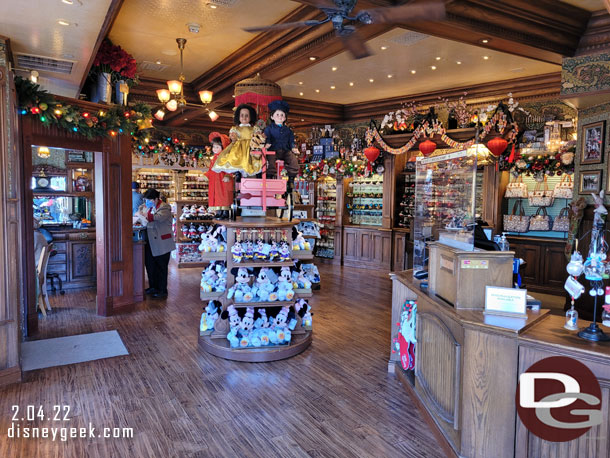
[278,28,561,104]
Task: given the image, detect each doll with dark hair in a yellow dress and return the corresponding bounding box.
[212,104,262,176]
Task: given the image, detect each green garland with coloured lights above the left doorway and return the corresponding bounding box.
[15,76,152,139]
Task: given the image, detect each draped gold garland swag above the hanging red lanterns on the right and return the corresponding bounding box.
[366,112,507,155]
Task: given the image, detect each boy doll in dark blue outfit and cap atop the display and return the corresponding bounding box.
[265,100,299,194]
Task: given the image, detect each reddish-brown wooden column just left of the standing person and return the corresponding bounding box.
[95,135,134,316]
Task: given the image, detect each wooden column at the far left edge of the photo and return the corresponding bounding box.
[0,37,24,386]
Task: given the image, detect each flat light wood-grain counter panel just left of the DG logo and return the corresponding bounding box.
[461,327,518,458]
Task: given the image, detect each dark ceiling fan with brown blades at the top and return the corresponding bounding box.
[244,0,445,59]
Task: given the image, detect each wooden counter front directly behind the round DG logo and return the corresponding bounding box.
[515,342,610,458]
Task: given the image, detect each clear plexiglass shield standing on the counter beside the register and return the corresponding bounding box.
[413,151,477,273]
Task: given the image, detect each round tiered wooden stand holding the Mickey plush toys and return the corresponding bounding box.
[199,217,312,362]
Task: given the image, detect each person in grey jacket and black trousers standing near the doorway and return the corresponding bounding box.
[138,189,176,299]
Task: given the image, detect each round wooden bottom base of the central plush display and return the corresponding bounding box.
[199,331,312,363]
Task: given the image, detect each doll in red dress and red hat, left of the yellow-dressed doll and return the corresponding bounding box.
[205,132,235,219]
